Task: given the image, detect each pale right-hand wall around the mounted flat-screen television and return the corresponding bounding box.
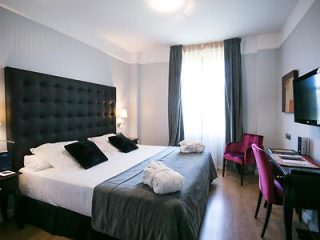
[277,1,320,161]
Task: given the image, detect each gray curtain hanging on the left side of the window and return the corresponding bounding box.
[168,45,184,146]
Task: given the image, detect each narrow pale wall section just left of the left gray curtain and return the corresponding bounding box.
[139,63,169,145]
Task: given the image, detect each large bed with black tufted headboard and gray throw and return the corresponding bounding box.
[5,67,217,239]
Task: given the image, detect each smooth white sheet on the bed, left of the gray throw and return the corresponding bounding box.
[19,145,166,216]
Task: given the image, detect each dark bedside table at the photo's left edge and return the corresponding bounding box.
[0,172,21,226]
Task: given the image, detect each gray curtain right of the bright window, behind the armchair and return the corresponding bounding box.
[224,38,243,143]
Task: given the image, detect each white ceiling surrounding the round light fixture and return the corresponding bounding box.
[0,0,310,62]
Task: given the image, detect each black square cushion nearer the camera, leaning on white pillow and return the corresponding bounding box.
[64,140,108,169]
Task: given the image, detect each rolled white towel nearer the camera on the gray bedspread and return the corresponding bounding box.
[143,161,184,194]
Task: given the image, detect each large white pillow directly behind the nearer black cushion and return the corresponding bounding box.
[30,141,81,170]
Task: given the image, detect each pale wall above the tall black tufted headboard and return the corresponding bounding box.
[0,8,130,145]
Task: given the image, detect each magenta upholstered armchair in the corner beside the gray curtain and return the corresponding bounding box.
[222,133,263,186]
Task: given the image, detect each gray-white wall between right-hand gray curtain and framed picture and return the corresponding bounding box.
[230,49,280,147]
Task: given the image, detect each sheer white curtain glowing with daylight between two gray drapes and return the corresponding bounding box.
[181,42,225,168]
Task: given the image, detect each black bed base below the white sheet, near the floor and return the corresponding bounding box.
[20,196,116,240]
